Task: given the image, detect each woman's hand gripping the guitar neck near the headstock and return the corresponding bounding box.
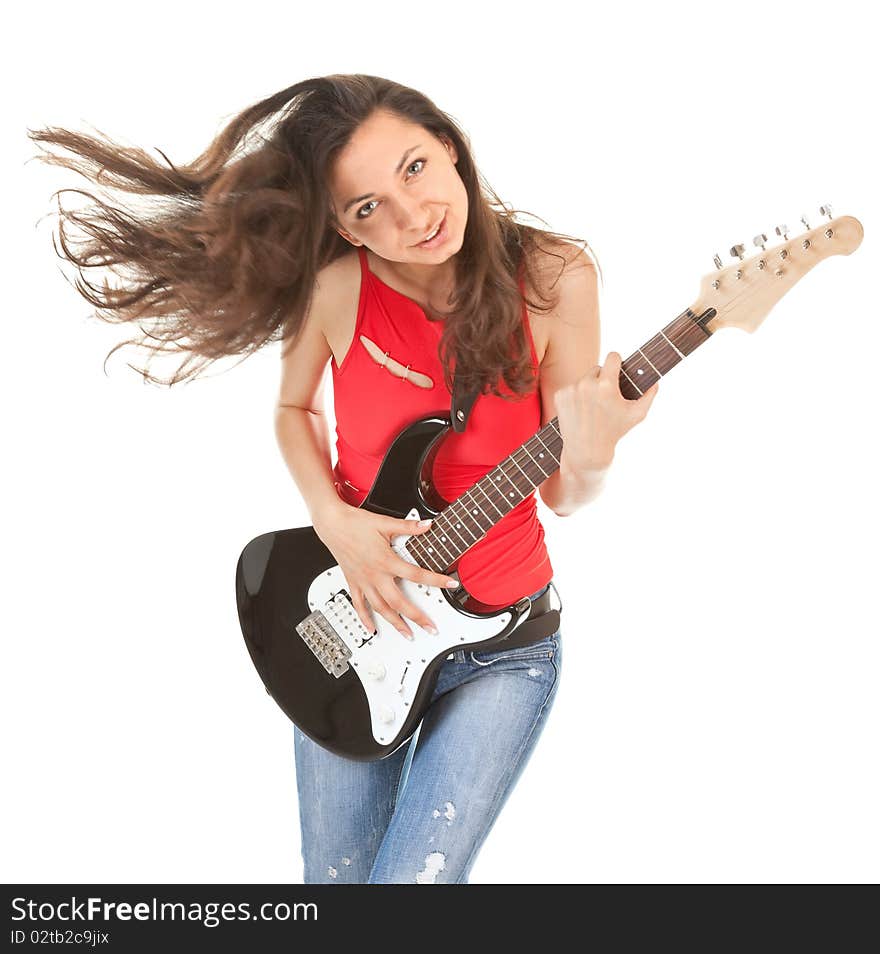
[554,351,660,470]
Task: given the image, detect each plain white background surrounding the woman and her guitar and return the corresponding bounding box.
[2,2,880,884]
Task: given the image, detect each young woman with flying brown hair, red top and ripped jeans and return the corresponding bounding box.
[29,74,657,884]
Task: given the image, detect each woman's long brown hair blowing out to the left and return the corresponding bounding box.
[28,74,600,396]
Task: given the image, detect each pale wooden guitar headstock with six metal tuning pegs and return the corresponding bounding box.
[691,205,864,332]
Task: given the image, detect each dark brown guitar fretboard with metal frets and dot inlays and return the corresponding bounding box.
[406,309,715,573]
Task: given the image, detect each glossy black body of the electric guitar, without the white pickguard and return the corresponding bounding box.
[235,415,521,761]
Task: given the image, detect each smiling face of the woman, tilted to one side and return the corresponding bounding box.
[327,111,468,272]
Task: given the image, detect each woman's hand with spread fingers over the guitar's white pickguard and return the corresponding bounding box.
[312,500,459,639]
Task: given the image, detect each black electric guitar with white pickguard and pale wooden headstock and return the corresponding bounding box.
[235,206,863,761]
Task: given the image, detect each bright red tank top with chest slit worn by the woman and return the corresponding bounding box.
[331,246,553,605]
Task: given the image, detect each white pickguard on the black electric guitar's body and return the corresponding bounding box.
[308,510,513,745]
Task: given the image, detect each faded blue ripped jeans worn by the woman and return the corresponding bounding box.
[293,587,562,884]
